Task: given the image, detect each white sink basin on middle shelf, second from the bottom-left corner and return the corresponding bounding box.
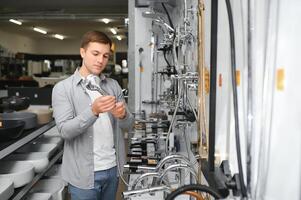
[3,152,49,173]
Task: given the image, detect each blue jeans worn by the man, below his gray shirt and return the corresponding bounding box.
[68,167,119,200]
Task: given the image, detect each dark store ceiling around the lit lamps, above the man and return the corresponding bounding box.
[0,0,128,39]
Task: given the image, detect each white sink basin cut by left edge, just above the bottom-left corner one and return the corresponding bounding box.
[0,161,34,188]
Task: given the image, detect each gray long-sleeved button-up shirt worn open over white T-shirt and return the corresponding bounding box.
[52,69,134,189]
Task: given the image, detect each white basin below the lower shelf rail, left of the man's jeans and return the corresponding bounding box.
[30,179,65,200]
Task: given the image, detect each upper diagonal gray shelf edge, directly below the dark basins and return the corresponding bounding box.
[0,121,55,159]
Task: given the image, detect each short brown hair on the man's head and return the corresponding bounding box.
[80,31,112,49]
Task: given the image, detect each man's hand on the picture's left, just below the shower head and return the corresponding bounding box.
[92,96,116,116]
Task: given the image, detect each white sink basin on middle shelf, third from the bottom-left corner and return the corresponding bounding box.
[16,143,57,159]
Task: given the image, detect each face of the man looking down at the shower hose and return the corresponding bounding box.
[80,42,111,75]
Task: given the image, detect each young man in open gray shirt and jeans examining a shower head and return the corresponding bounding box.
[52,31,134,200]
